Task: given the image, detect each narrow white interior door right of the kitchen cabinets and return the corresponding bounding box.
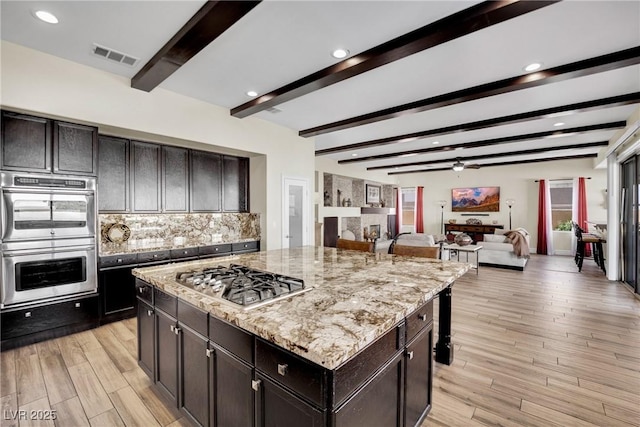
[282,178,309,248]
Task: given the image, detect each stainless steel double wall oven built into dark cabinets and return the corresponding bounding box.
[0,172,98,308]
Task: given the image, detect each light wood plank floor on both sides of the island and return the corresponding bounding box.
[0,255,640,427]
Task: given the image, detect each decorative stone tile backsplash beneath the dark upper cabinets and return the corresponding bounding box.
[98,213,260,245]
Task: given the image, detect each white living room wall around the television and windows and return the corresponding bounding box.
[396,158,607,249]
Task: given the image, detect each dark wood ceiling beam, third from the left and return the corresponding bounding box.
[299,46,640,137]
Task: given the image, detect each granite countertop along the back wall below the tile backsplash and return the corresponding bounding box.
[99,237,258,256]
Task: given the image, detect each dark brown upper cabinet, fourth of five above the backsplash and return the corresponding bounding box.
[189,150,222,212]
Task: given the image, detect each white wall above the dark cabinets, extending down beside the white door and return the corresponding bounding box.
[0,41,315,249]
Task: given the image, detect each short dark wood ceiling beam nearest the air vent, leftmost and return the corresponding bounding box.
[131,0,261,92]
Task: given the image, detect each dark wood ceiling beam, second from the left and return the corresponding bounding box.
[231,0,557,118]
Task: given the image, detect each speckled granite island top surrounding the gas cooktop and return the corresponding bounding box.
[133,246,470,369]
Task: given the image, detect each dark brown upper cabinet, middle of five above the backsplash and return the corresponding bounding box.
[162,145,189,212]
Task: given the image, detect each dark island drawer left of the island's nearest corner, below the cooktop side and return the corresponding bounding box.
[256,338,326,407]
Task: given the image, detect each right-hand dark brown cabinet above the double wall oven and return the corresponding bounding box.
[53,121,98,176]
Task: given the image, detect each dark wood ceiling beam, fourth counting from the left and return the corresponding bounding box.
[316,92,640,156]
